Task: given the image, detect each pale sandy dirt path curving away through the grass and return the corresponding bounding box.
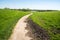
[9,14,35,40]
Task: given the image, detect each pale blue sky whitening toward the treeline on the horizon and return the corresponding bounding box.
[0,0,60,10]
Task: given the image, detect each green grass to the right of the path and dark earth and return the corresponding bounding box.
[30,12,60,40]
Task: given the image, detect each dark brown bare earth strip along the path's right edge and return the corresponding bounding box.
[28,19,50,40]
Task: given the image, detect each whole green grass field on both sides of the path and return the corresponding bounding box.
[0,9,60,40]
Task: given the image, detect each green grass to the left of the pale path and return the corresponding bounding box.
[0,9,28,40]
